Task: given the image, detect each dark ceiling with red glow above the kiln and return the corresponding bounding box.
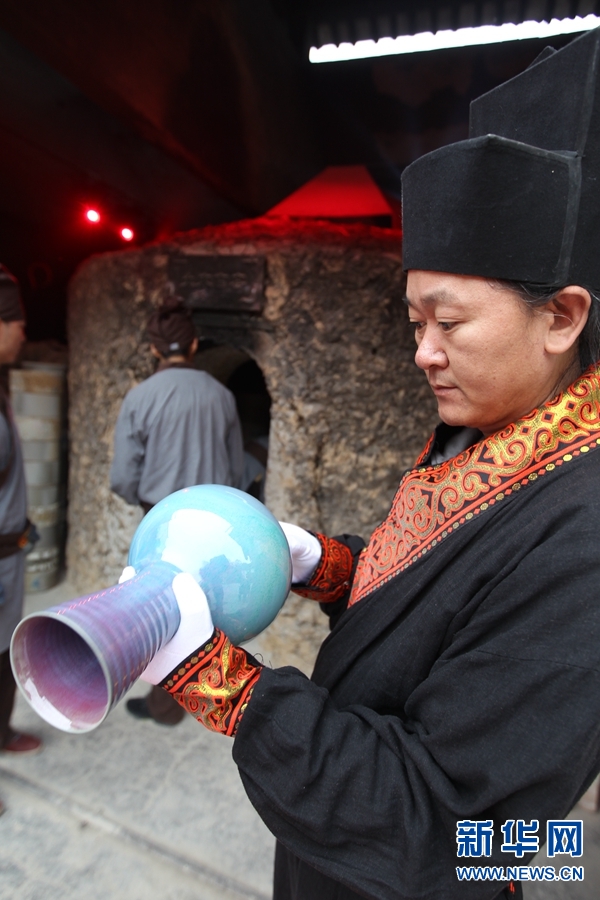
[0,0,584,339]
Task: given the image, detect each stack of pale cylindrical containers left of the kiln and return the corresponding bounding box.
[9,362,66,593]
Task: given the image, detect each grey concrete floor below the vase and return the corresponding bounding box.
[0,583,600,900]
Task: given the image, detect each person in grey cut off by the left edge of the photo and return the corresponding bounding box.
[0,265,41,813]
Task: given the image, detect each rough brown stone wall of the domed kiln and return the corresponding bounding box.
[67,219,435,669]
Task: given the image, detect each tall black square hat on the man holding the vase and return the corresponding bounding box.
[402,29,600,289]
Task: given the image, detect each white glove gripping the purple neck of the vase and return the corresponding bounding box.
[119,566,214,684]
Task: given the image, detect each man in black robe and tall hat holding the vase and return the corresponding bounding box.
[120,30,600,900]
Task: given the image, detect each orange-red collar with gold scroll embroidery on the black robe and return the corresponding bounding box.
[349,365,600,606]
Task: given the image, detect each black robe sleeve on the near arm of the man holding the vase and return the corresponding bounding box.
[233,502,600,900]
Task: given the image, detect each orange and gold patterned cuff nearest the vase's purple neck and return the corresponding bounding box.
[161,628,262,737]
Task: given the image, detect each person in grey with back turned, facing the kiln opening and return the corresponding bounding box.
[110,297,244,725]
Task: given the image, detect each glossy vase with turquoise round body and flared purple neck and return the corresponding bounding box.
[11,484,292,733]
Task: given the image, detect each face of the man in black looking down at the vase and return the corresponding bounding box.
[406,270,564,434]
